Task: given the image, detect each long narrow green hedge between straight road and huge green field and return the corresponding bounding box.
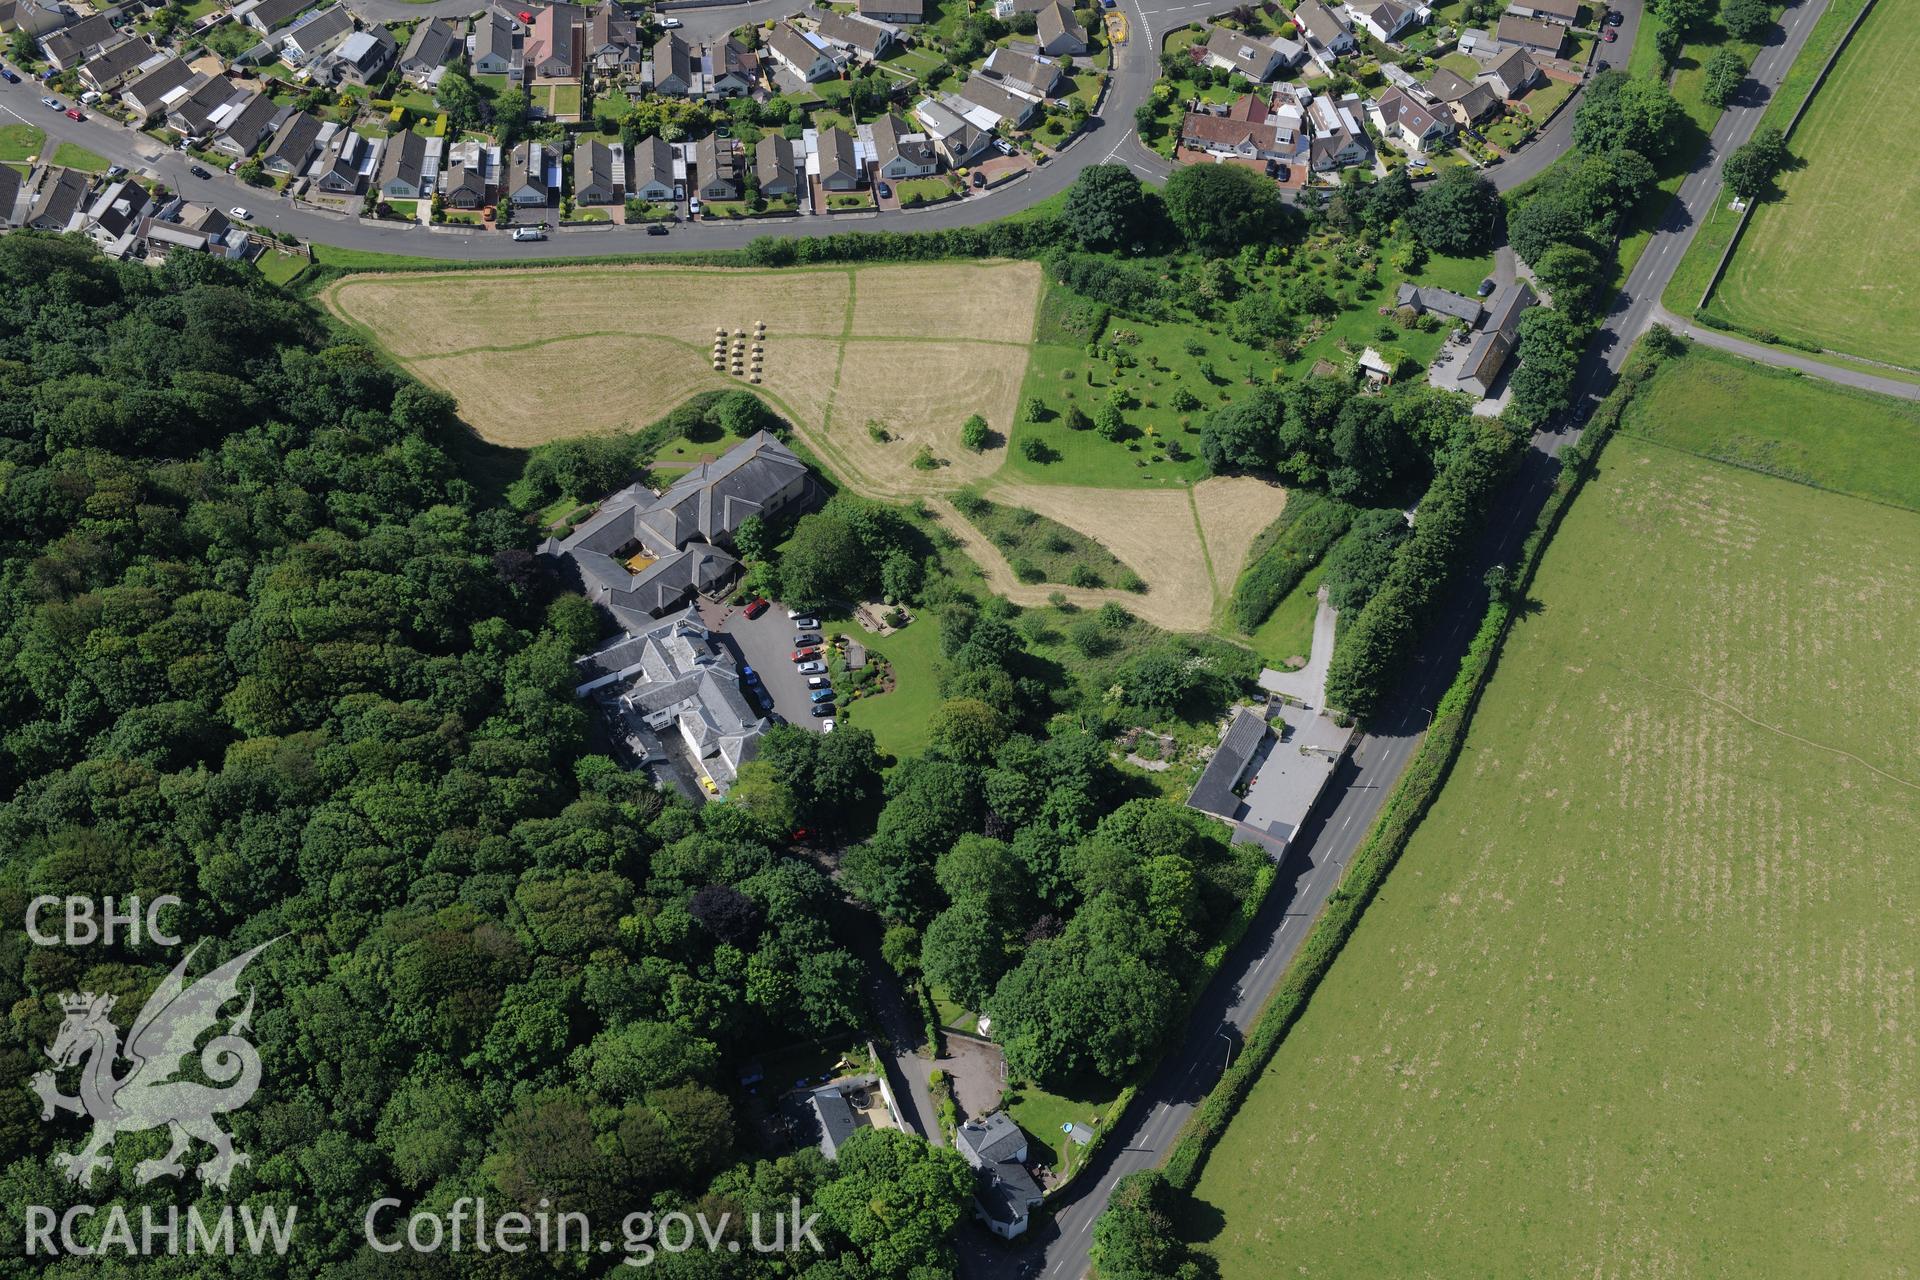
[1165,326,1686,1192]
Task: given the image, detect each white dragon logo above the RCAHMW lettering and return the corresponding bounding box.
[33,938,278,1188]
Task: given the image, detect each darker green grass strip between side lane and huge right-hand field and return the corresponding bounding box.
[1624,347,1920,510]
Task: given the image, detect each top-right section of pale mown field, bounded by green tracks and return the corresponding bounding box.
[852,263,1041,339]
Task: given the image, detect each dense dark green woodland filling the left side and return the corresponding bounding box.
[0,234,968,1280]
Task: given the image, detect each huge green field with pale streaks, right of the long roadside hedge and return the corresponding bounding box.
[1194,359,1920,1280]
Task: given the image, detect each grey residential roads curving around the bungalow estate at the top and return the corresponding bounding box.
[0,0,1605,261]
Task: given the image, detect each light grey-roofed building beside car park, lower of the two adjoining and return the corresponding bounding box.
[574,604,766,794]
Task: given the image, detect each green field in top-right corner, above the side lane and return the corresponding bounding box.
[1715,4,1920,368]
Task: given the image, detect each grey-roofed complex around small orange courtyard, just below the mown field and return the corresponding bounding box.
[541,432,810,629]
